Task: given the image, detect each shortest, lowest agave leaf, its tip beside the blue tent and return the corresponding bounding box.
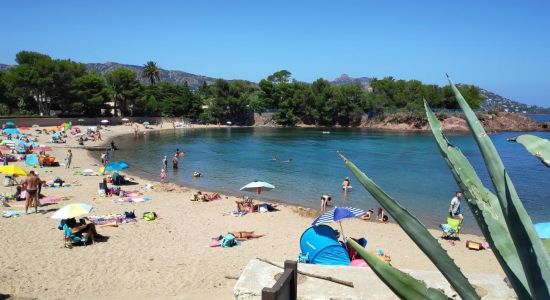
[348,238,450,299]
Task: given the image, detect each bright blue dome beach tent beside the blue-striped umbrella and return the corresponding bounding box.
[300,225,350,266]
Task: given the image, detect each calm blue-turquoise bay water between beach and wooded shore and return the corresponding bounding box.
[110,128,550,232]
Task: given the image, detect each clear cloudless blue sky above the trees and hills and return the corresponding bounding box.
[0,0,550,106]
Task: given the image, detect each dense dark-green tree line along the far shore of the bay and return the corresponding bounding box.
[0,51,483,126]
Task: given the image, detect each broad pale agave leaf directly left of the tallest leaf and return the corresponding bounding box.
[424,100,531,299]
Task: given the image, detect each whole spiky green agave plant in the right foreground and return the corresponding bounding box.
[348,78,550,299]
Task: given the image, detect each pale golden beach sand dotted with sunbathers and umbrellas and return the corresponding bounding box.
[0,126,504,299]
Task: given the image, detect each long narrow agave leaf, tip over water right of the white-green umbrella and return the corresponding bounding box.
[338,153,479,299]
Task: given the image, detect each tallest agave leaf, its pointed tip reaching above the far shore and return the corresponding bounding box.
[448,78,550,299]
